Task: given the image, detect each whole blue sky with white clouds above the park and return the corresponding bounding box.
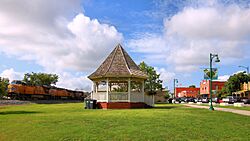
[0,0,250,90]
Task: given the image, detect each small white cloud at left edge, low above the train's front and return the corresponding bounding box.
[0,68,24,82]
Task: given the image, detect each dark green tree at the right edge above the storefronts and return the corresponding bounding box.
[222,72,250,95]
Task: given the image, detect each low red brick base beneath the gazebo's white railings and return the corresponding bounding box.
[97,102,151,109]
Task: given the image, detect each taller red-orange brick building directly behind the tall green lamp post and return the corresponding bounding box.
[200,80,225,97]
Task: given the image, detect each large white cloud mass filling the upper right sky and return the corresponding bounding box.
[128,2,250,72]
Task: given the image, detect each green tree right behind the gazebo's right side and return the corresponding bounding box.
[139,62,162,94]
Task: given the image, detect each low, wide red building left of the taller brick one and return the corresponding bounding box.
[175,87,200,97]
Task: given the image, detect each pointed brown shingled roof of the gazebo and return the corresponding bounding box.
[88,44,148,80]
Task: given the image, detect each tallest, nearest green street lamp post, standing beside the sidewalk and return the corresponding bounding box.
[209,53,220,110]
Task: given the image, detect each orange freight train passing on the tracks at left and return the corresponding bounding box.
[7,80,88,100]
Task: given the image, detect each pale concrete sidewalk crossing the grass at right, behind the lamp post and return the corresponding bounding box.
[185,104,250,116]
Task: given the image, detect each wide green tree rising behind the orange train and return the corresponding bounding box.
[23,72,59,86]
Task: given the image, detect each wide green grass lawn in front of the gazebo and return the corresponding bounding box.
[0,103,250,141]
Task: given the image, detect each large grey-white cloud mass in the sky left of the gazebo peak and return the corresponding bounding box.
[0,0,123,71]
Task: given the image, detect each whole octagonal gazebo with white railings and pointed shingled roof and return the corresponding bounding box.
[88,44,154,109]
